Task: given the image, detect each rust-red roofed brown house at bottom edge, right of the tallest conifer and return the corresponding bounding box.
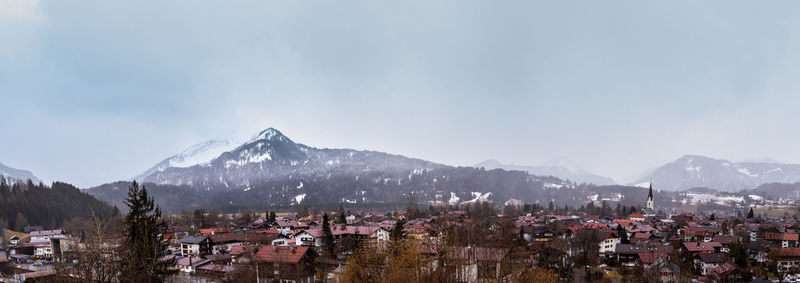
[253,246,316,283]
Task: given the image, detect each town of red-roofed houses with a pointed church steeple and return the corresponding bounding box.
[0,184,800,282]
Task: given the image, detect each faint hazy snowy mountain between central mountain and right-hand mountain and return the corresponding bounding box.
[475,159,616,185]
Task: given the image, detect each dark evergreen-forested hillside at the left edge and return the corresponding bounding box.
[0,179,119,231]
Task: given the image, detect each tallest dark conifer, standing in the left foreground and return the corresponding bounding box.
[119,181,175,282]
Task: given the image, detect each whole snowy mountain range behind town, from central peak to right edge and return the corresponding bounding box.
[81,128,800,213]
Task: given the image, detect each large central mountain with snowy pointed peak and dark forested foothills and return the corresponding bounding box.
[87,128,604,212]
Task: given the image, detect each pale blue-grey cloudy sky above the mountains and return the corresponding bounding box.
[0,0,800,187]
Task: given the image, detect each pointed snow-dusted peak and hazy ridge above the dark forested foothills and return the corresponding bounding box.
[134,128,442,190]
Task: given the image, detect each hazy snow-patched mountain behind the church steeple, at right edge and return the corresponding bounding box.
[638,155,800,192]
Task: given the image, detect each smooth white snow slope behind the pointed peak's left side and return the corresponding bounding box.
[133,139,238,180]
